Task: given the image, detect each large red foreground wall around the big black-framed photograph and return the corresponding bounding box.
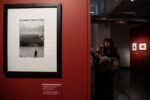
[0,0,90,100]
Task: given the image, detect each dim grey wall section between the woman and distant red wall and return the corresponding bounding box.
[111,24,133,67]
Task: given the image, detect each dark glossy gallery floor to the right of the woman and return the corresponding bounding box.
[92,69,150,100]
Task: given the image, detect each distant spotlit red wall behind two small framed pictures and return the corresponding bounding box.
[130,25,150,76]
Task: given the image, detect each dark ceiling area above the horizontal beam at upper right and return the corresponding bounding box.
[107,0,150,19]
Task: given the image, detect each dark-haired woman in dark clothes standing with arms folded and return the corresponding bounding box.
[95,38,119,100]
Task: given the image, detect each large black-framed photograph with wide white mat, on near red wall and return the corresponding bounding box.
[3,4,62,78]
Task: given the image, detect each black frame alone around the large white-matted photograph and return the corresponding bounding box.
[3,3,62,78]
